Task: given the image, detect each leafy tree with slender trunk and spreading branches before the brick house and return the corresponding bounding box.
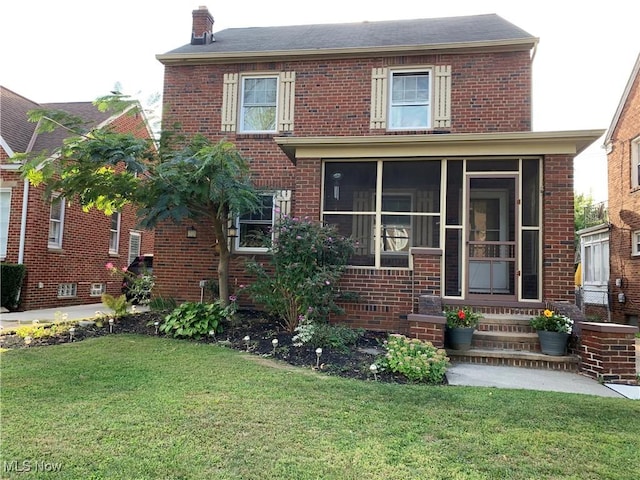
[15,93,258,305]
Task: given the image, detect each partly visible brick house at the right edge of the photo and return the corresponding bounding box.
[605,55,640,326]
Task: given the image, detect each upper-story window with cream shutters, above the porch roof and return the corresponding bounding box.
[369,65,451,130]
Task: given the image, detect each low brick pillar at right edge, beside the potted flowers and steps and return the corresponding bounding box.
[579,322,638,385]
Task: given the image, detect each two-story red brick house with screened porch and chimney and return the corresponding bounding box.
[154,7,604,331]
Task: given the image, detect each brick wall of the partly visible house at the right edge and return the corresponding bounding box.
[607,70,640,323]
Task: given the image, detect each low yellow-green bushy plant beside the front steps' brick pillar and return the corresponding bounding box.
[378,334,449,385]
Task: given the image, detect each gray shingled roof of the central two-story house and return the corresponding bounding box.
[167,14,537,55]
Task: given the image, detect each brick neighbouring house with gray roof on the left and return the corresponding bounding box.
[0,87,154,309]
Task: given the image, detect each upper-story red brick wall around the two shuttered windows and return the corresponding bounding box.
[163,52,531,140]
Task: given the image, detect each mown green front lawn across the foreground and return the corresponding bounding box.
[0,335,640,480]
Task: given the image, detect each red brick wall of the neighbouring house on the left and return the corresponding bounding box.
[1,110,154,310]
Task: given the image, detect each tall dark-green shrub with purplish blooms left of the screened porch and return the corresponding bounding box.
[247,216,354,332]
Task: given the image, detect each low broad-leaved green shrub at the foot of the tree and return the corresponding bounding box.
[159,301,236,339]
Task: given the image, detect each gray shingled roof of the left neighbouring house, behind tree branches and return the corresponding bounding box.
[0,86,112,159]
